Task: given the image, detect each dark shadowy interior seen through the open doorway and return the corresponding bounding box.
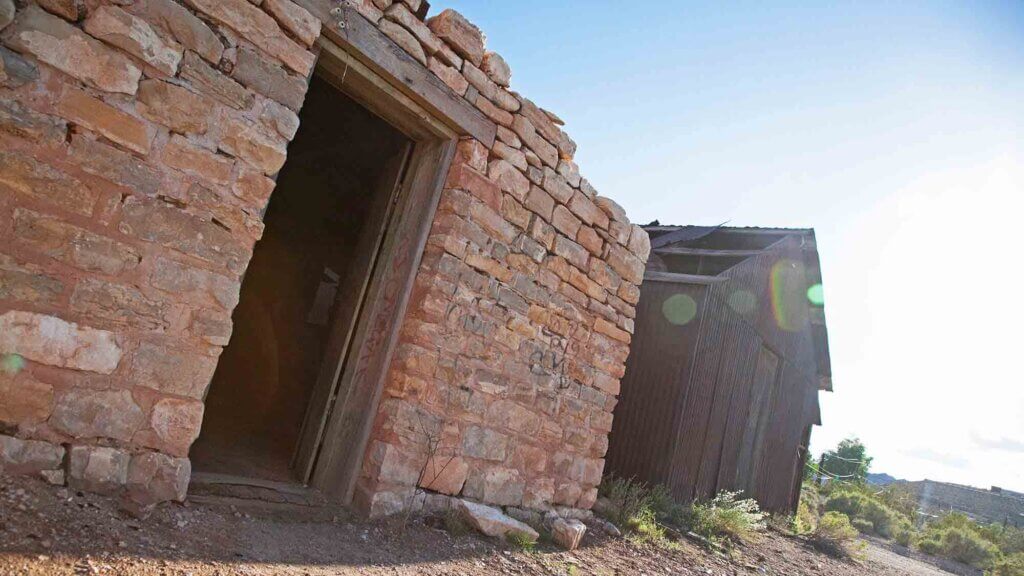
[190,77,409,482]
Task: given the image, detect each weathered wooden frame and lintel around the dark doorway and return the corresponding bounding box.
[286,7,497,504]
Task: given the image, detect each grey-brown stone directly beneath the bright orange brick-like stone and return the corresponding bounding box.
[71,135,164,196]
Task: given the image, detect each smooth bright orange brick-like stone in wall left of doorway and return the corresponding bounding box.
[57,86,152,154]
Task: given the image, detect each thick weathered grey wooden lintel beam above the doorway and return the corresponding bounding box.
[295,0,498,148]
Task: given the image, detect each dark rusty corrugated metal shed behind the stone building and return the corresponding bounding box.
[608,222,831,510]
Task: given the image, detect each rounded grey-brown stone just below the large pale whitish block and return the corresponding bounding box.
[50,388,145,442]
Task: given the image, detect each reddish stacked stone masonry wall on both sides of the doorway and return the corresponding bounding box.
[0,0,649,515]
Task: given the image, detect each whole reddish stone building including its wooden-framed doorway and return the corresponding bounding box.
[0,0,649,515]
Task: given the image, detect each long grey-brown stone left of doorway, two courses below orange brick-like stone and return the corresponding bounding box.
[118,197,249,273]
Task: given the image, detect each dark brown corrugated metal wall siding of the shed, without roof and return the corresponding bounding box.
[608,230,818,510]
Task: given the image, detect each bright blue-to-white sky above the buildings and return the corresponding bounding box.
[431,0,1024,491]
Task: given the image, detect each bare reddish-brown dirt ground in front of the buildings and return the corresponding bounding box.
[0,477,962,576]
